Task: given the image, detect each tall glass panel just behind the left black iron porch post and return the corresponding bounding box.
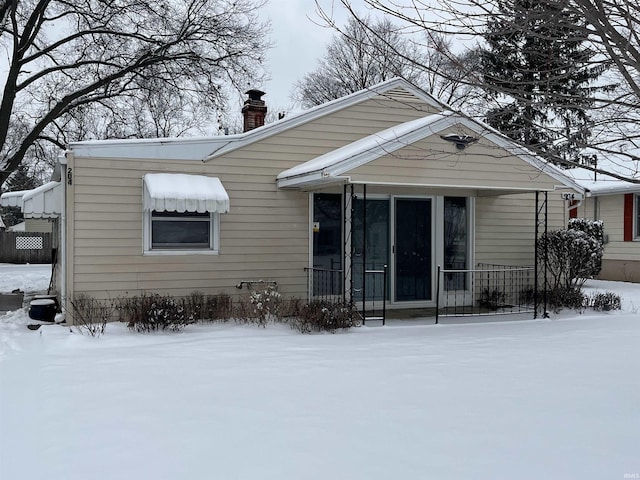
[352,199,390,300]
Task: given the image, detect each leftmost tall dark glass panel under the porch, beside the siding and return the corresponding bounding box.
[313,193,342,295]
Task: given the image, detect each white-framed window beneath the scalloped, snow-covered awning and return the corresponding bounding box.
[145,210,219,253]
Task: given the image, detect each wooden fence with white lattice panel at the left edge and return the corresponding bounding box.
[0,232,53,263]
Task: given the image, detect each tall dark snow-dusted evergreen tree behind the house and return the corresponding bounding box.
[481,0,606,163]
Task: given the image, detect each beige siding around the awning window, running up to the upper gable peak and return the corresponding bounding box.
[68,91,440,298]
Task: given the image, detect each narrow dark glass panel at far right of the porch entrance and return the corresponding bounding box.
[443,197,469,290]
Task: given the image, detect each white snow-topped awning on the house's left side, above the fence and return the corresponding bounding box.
[0,182,64,218]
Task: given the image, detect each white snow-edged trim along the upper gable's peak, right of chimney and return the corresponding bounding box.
[204,78,447,162]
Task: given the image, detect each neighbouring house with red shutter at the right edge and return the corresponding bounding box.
[566,147,640,282]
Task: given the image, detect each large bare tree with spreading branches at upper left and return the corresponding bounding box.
[0,0,267,184]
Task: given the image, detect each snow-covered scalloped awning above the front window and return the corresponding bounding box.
[144,173,229,213]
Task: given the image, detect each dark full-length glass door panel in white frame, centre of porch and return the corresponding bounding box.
[395,198,432,301]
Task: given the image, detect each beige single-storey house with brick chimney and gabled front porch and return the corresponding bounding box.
[22,79,582,322]
